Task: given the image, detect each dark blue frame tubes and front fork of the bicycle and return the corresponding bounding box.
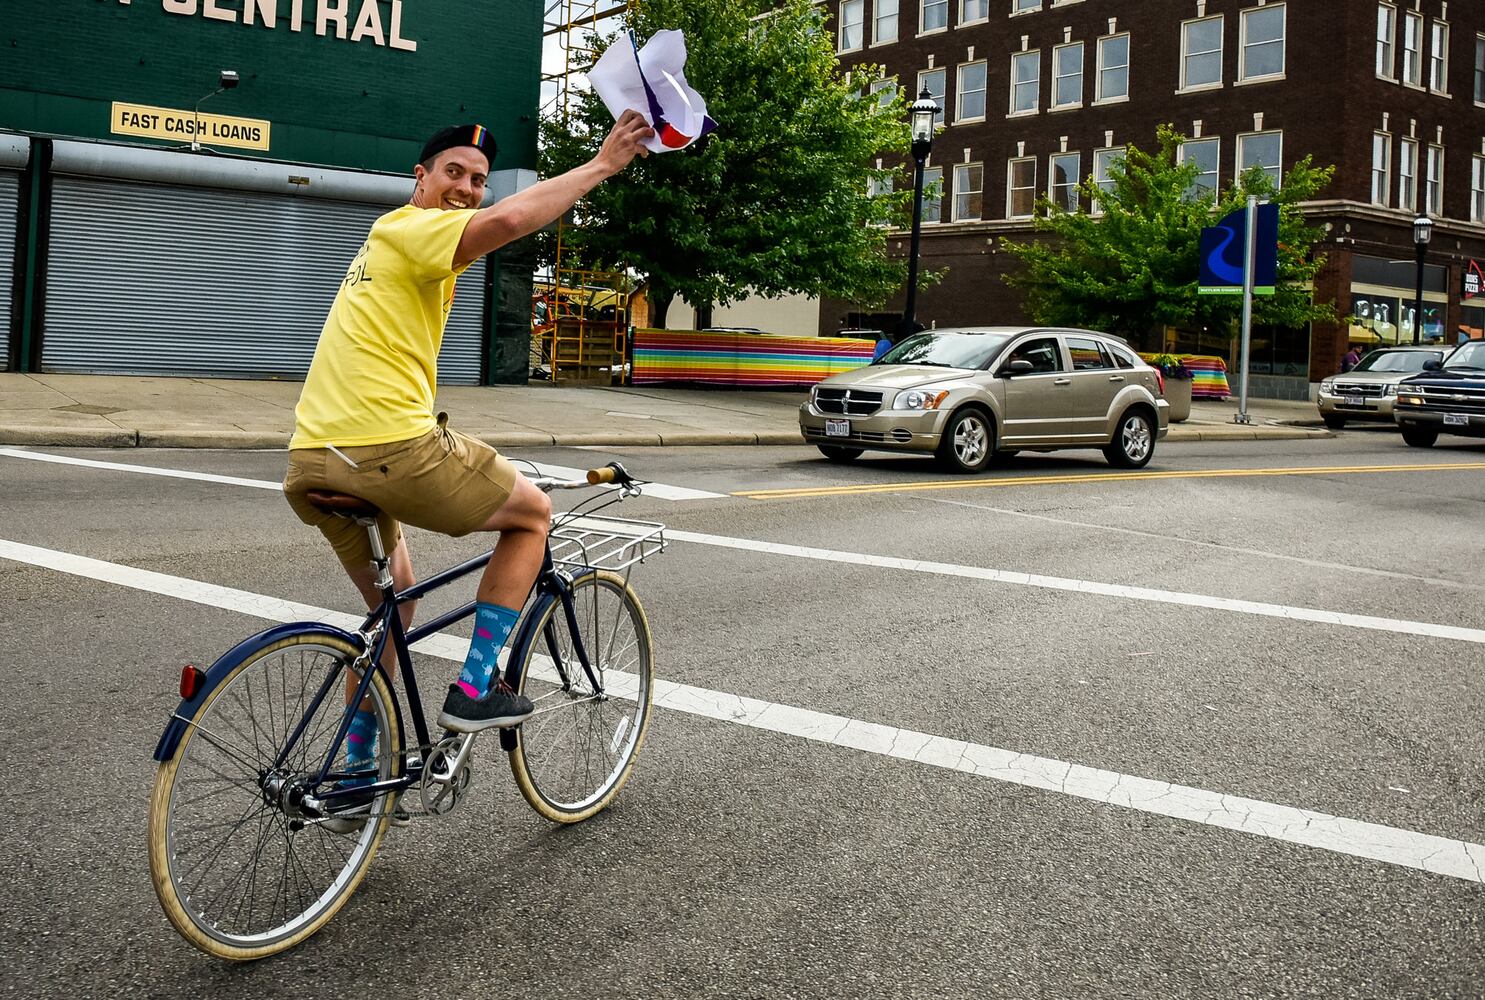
[295,529,603,802]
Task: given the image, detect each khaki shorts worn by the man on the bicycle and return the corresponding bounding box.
[284,413,518,569]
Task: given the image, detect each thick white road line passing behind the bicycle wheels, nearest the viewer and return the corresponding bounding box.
[0,539,1485,883]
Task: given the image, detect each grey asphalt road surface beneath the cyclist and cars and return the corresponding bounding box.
[0,429,1485,997]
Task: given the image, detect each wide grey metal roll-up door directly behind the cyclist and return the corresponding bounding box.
[42,175,487,383]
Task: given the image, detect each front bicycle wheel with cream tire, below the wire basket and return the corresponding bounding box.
[511,571,655,823]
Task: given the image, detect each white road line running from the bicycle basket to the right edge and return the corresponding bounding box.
[665,527,1485,643]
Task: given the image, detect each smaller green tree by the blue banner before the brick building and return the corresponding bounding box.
[1005,125,1335,336]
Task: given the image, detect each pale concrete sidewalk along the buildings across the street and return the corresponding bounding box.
[0,373,1332,449]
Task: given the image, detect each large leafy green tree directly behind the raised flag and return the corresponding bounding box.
[542,0,912,325]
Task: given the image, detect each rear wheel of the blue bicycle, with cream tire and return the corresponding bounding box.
[149,629,402,961]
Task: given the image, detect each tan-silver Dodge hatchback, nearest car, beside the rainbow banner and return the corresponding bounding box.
[799,327,1169,473]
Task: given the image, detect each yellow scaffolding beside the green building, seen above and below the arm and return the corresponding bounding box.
[532,0,633,383]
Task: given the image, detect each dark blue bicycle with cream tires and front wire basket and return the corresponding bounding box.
[150,462,665,960]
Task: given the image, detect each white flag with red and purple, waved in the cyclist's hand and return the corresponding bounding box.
[588,31,717,153]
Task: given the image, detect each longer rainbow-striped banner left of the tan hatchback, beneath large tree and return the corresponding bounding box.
[631,330,876,389]
